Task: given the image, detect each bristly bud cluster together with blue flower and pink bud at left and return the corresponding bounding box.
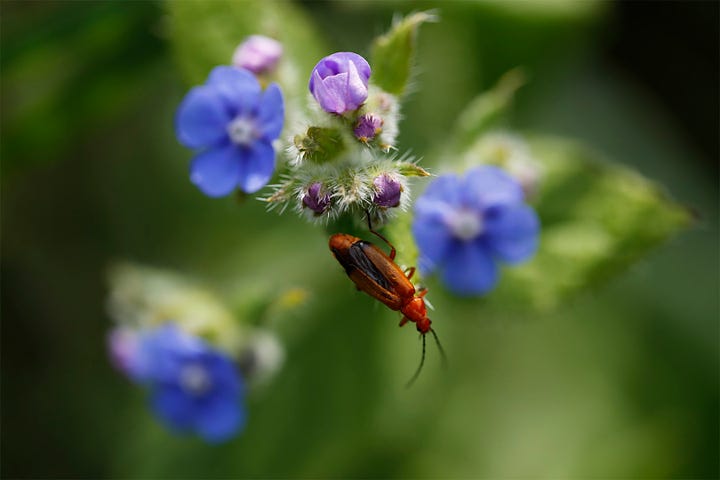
[176,35,428,223]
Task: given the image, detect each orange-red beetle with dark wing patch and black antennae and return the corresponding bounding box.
[329,219,445,386]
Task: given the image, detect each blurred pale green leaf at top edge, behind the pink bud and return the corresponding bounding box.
[167,0,323,103]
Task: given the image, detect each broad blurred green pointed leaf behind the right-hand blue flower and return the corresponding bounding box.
[488,136,691,310]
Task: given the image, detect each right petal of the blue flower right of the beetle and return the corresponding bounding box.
[484,205,540,263]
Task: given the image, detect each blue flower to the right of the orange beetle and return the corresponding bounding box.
[412,166,540,295]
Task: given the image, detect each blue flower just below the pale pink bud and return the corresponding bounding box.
[176,66,285,197]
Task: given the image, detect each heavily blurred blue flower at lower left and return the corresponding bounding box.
[128,324,245,442]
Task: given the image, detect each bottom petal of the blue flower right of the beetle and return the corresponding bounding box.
[442,241,498,296]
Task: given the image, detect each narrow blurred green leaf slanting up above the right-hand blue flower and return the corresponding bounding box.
[454,68,526,149]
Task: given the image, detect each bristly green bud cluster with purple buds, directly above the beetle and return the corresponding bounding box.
[267,52,427,223]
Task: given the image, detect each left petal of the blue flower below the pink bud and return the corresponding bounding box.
[175,86,230,148]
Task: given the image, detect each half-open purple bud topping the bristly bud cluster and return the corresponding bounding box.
[308,52,370,114]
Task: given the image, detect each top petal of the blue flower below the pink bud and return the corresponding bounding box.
[206,65,261,117]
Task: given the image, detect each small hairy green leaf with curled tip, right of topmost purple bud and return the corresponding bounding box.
[371,12,437,95]
